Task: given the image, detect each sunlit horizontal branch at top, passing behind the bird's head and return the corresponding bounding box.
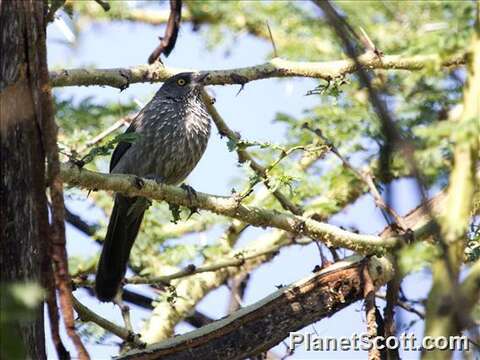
[50,54,465,89]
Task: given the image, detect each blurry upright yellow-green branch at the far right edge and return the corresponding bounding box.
[422,30,480,359]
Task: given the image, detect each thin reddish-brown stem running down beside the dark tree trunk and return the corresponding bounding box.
[35,3,90,360]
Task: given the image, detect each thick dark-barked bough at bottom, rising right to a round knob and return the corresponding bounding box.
[119,256,393,359]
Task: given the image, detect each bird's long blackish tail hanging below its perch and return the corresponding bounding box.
[95,194,147,301]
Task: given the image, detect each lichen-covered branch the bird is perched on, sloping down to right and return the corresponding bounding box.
[61,164,399,254]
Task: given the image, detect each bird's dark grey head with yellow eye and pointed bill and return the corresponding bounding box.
[159,72,209,99]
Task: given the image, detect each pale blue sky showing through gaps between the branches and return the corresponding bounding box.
[47,3,438,359]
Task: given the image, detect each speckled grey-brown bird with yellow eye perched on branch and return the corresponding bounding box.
[95,72,211,302]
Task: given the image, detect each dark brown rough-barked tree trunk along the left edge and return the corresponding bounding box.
[0,0,49,359]
